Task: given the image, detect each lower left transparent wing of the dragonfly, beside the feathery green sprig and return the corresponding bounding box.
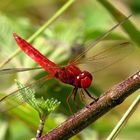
[0,75,53,112]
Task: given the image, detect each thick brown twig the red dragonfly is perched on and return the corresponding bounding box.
[38,71,140,140]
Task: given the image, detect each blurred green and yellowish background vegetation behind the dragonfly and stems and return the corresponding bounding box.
[0,0,140,140]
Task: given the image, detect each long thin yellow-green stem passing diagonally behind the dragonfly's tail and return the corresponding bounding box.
[0,0,75,68]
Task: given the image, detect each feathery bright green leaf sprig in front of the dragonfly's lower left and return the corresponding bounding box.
[16,81,60,116]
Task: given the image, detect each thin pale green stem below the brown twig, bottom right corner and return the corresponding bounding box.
[107,95,140,140]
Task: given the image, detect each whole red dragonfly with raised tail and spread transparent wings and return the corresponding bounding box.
[0,16,132,112]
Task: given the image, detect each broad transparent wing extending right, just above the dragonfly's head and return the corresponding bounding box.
[74,41,133,73]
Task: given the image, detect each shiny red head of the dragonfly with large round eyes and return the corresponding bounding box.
[74,71,92,89]
